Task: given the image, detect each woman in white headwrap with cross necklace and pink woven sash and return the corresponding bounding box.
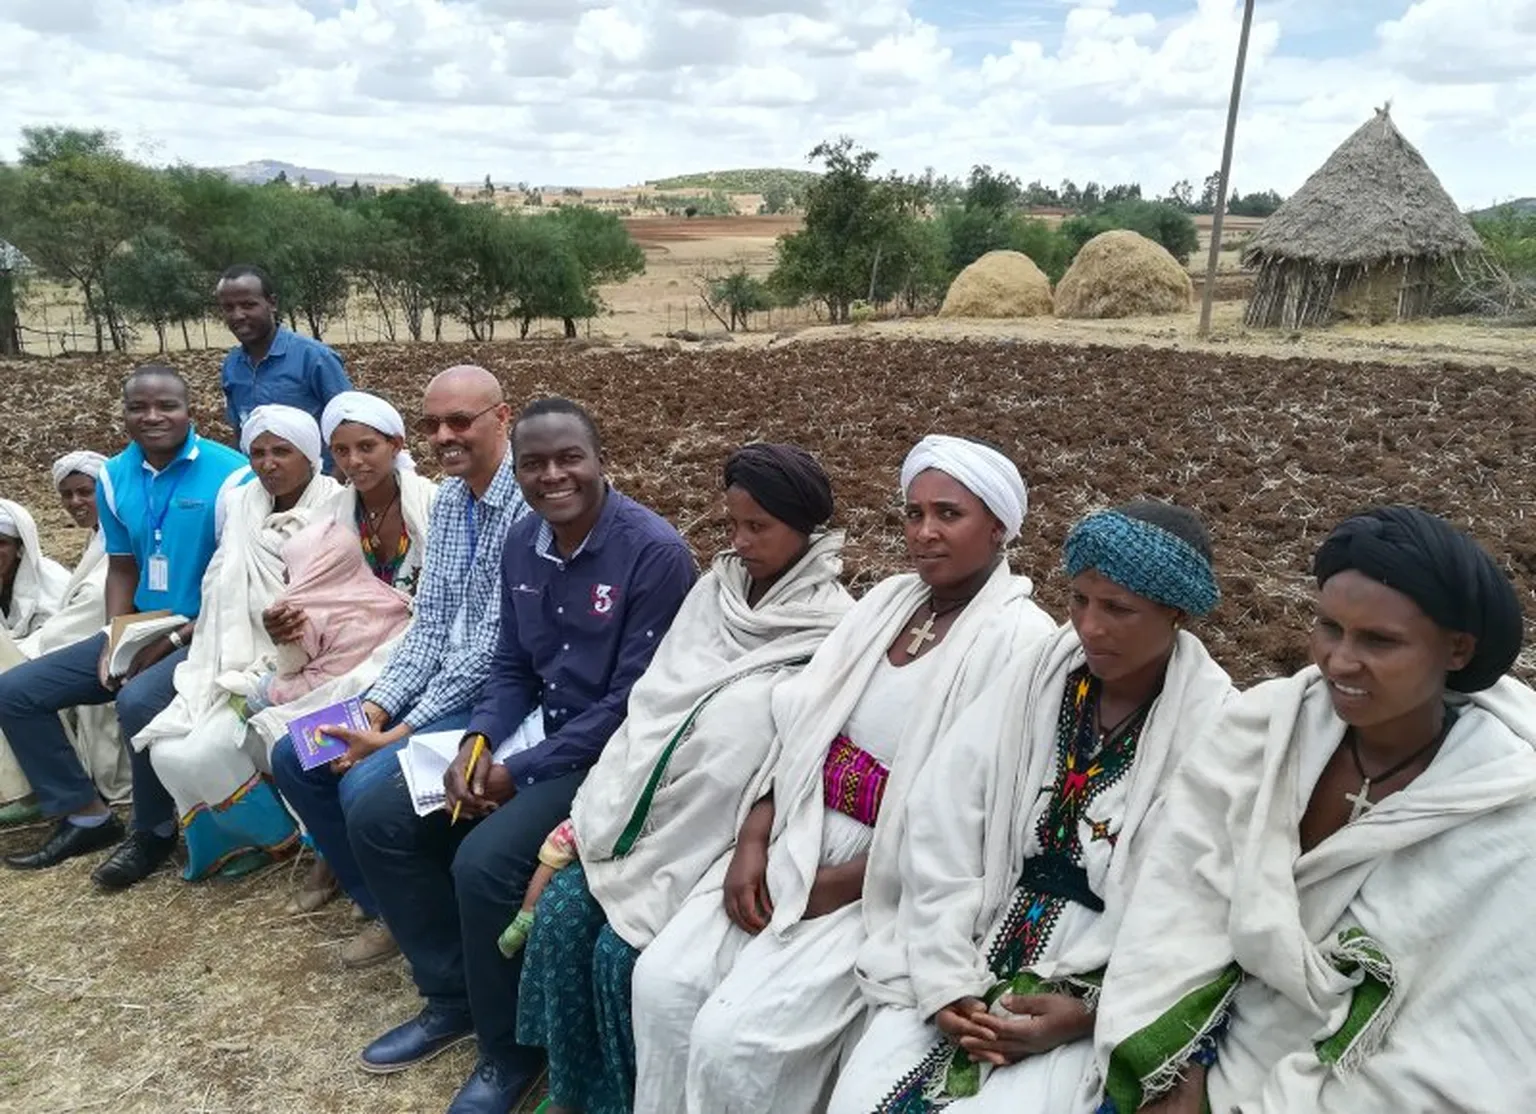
[633,436,1055,1114]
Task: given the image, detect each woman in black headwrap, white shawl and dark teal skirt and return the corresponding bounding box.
[502,444,852,1114]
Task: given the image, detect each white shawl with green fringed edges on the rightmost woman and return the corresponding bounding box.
[1095,667,1536,1114]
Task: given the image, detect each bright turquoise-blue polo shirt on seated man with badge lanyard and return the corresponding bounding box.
[97,429,250,619]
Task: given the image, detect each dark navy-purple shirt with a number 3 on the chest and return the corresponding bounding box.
[468,489,697,788]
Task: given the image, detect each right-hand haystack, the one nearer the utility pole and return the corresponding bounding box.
[1055,229,1195,318]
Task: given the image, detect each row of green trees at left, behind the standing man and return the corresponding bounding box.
[0,128,645,352]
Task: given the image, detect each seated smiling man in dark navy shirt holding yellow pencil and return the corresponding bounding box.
[347,398,697,1114]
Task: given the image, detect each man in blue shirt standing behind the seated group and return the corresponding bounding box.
[215,263,352,472]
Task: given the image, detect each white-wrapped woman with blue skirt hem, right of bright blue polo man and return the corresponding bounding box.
[132,406,336,880]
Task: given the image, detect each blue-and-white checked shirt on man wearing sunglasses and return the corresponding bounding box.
[367,446,528,730]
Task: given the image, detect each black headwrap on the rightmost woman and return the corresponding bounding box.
[1312,507,1525,693]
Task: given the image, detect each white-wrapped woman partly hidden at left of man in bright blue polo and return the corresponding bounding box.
[0,450,134,827]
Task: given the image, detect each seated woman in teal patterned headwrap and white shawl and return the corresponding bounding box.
[828,501,1233,1114]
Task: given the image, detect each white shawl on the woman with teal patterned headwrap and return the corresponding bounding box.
[859,624,1233,1017]
